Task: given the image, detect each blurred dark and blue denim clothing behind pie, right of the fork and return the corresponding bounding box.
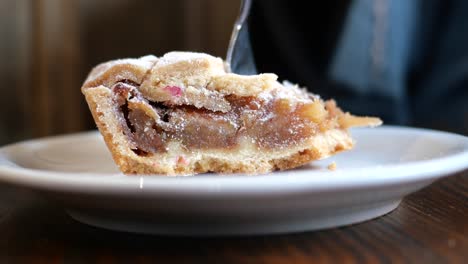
[249,0,468,134]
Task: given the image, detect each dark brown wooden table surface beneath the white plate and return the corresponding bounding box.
[0,170,468,264]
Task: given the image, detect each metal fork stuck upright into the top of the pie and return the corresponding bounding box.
[225,0,257,75]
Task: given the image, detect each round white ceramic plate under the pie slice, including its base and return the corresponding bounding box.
[0,126,468,235]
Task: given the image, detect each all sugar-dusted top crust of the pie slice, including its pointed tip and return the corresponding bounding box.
[82,51,382,128]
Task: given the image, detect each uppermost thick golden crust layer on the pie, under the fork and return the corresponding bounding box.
[83,52,278,97]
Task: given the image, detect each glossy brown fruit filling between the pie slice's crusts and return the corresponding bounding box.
[112,82,338,156]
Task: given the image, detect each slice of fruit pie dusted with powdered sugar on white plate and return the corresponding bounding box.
[82,52,381,175]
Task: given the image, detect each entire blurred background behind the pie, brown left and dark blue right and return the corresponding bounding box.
[0,0,468,145]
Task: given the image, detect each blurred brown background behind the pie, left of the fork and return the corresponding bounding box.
[0,0,240,145]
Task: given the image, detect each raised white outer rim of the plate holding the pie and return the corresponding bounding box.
[0,125,468,195]
